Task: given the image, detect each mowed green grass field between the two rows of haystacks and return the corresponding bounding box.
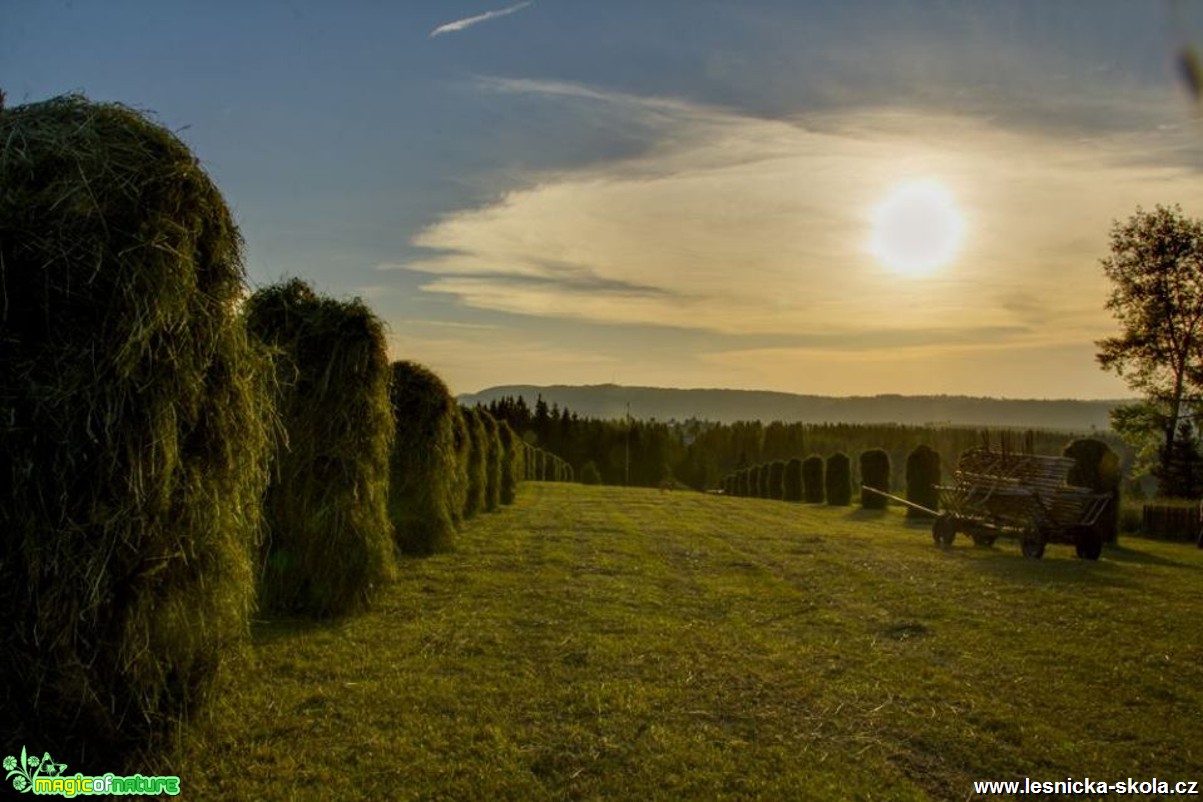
[171,483,1203,800]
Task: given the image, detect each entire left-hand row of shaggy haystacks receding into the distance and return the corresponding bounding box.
[0,96,563,771]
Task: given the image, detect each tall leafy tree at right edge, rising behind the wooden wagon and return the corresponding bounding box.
[1096,206,1203,495]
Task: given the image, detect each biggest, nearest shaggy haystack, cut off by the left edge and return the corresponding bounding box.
[0,96,273,771]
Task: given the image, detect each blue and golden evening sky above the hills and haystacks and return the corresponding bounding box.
[7,0,1203,398]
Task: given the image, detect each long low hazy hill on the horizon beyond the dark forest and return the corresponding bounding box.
[460,385,1124,432]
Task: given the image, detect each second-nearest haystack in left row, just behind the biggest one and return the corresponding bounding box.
[247,279,395,618]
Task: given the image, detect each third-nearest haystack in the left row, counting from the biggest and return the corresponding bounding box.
[389,362,460,554]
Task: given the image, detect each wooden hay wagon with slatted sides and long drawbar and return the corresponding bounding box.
[866,448,1110,559]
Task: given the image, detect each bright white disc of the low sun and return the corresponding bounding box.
[869,180,965,275]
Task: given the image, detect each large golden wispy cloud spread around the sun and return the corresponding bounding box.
[383,81,1203,351]
